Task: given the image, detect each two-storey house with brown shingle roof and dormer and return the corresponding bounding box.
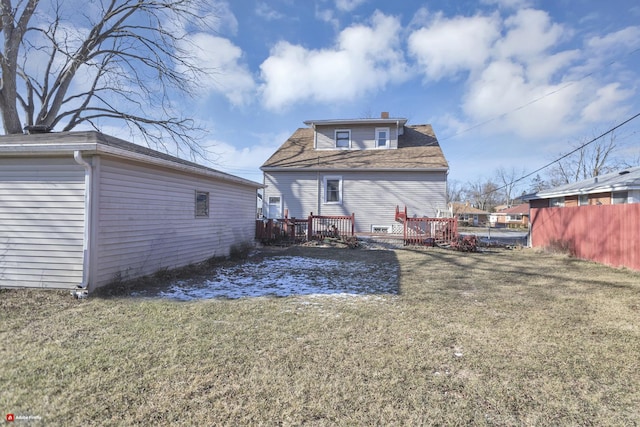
[261,113,449,232]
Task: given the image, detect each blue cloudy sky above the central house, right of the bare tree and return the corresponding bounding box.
[38,0,640,189]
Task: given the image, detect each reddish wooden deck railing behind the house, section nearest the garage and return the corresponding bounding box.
[256,212,355,243]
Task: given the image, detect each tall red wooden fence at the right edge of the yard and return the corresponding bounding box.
[531,203,640,270]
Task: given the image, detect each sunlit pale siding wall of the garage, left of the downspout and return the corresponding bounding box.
[0,157,84,288]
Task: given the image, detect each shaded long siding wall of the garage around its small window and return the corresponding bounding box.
[93,158,256,286]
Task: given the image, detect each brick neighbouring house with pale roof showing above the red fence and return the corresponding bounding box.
[523,166,640,208]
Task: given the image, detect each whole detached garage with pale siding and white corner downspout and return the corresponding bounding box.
[0,132,262,291]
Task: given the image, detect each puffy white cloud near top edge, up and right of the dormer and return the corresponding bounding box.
[408,14,500,80]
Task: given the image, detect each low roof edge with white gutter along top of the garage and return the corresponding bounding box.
[0,131,263,188]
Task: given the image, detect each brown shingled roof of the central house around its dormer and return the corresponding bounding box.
[260,123,449,170]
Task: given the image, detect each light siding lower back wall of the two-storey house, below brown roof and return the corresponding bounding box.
[265,172,446,232]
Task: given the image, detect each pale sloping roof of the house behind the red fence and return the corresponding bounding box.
[522,166,640,200]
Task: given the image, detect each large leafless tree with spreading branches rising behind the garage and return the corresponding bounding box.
[0,0,211,155]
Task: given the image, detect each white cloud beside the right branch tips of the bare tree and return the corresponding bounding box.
[184,33,256,106]
